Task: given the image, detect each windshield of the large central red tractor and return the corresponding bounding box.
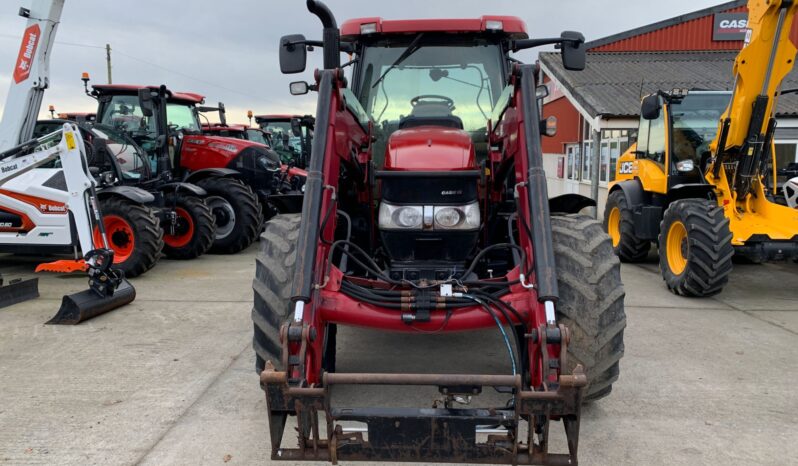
[355,33,504,164]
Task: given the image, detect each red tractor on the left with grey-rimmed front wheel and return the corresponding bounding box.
[83,82,264,254]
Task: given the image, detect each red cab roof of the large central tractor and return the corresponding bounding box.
[341,16,528,40]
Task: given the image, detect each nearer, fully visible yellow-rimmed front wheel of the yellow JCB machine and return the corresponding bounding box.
[659,199,734,297]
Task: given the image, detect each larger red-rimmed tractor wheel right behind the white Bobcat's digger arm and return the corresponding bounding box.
[95,196,164,278]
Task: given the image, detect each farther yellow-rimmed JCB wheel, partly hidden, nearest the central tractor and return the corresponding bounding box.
[604,190,651,262]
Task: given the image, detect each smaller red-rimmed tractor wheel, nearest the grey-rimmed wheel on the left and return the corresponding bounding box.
[163,194,216,260]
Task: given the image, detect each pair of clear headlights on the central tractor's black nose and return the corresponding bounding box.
[378,202,480,230]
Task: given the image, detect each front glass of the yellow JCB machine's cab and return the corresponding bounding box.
[669,92,731,163]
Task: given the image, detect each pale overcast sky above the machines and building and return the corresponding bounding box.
[0,0,720,123]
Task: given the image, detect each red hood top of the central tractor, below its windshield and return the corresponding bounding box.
[385,126,476,171]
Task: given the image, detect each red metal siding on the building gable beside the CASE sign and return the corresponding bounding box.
[590,6,798,52]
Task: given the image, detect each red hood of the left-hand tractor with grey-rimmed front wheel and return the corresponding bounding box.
[180,134,268,171]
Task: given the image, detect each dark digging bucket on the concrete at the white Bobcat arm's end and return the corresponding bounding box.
[47,279,136,325]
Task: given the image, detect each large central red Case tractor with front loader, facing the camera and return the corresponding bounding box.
[252,0,626,464]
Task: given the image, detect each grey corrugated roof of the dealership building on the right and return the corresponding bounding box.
[539,51,798,117]
